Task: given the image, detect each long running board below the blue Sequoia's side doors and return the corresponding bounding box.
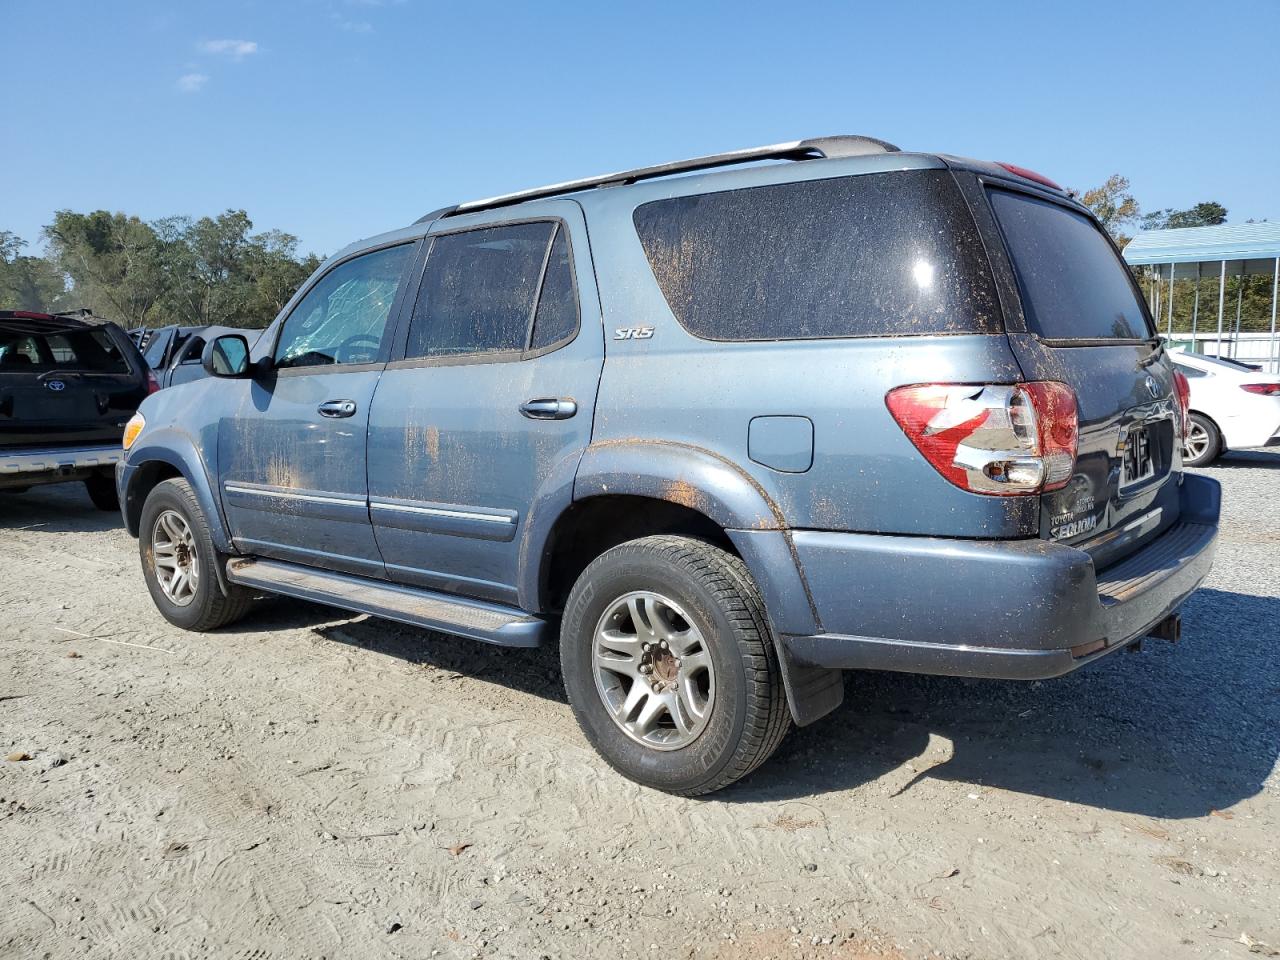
[227,557,548,646]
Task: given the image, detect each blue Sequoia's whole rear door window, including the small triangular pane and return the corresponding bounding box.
[404,221,577,358]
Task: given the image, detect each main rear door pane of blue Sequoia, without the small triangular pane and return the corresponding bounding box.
[404,223,556,357]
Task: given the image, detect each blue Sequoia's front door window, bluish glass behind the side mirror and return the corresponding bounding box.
[275,243,412,366]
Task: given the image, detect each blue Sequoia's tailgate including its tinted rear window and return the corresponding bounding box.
[986,187,1181,568]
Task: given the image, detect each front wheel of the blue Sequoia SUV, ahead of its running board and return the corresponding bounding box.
[138,477,252,631]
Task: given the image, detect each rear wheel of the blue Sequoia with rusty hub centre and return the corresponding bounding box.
[561,536,791,796]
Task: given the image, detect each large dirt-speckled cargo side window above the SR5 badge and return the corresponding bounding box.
[634,170,1001,340]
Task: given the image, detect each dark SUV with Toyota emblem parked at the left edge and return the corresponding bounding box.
[0,310,156,511]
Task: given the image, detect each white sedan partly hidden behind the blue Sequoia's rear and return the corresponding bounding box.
[1170,351,1280,467]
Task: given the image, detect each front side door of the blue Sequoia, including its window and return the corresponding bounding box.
[218,243,417,577]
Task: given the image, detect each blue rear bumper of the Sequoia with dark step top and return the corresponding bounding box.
[783,475,1220,680]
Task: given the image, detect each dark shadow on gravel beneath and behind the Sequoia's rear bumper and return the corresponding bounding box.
[716,590,1280,818]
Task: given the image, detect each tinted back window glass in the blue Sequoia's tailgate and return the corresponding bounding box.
[989,189,1152,340]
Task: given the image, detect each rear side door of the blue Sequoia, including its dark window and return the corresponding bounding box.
[369,207,603,603]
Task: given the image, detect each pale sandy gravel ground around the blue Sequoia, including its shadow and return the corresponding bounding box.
[0,453,1280,960]
